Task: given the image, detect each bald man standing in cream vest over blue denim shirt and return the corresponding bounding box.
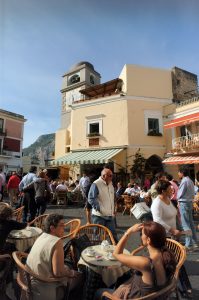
[88,168,117,242]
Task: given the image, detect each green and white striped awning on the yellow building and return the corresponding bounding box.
[51,148,123,166]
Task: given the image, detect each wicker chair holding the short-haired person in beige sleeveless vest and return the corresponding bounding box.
[12,251,69,300]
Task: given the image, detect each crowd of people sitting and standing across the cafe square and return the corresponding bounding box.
[0,167,198,300]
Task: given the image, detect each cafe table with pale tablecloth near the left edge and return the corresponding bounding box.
[7,226,42,252]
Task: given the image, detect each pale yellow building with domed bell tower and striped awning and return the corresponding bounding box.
[53,62,195,178]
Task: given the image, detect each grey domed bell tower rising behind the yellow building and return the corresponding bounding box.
[61,61,101,129]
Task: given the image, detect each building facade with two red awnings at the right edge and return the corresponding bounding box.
[163,96,199,178]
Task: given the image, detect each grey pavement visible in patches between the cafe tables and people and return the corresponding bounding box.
[46,206,199,300]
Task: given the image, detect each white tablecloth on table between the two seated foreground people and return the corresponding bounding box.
[78,245,130,287]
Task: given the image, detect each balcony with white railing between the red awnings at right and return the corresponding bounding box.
[172,133,199,153]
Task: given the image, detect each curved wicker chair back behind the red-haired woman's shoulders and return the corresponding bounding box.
[166,239,186,280]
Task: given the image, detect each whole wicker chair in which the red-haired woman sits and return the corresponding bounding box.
[103,239,186,300]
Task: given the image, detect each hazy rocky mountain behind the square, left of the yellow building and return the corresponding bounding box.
[23,133,55,164]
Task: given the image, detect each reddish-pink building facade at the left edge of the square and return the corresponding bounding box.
[0,109,26,173]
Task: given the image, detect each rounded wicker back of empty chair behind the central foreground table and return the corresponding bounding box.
[76,224,116,245]
